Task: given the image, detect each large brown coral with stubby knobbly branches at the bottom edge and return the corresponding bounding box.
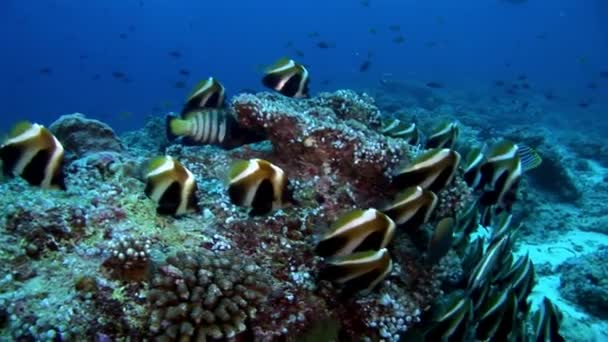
[148,250,268,341]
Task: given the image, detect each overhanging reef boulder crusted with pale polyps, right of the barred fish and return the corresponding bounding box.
[232,91,409,192]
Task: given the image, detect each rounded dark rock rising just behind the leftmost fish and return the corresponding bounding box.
[50,113,122,157]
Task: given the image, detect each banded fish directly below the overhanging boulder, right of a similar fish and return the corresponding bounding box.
[228,159,293,216]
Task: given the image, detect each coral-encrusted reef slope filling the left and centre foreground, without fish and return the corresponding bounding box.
[0,87,600,341]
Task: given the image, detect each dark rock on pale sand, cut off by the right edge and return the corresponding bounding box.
[560,246,608,319]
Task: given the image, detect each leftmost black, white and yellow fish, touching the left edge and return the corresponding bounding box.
[0,122,66,190]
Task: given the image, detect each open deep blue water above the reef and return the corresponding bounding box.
[0,0,608,130]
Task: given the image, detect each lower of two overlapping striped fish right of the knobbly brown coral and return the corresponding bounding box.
[319,248,393,294]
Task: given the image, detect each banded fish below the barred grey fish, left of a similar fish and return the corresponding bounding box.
[145,156,199,216]
